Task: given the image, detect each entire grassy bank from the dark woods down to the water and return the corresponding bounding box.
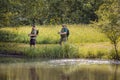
[0,25,119,59]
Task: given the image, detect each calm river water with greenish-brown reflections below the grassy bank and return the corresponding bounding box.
[0,59,120,80]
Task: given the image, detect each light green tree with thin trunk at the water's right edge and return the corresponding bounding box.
[97,0,120,59]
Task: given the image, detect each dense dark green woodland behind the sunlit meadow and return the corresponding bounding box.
[0,0,102,26]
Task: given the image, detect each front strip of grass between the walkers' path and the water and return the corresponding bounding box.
[0,42,120,59]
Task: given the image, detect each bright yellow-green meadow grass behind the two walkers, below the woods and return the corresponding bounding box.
[0,25,108,44]
